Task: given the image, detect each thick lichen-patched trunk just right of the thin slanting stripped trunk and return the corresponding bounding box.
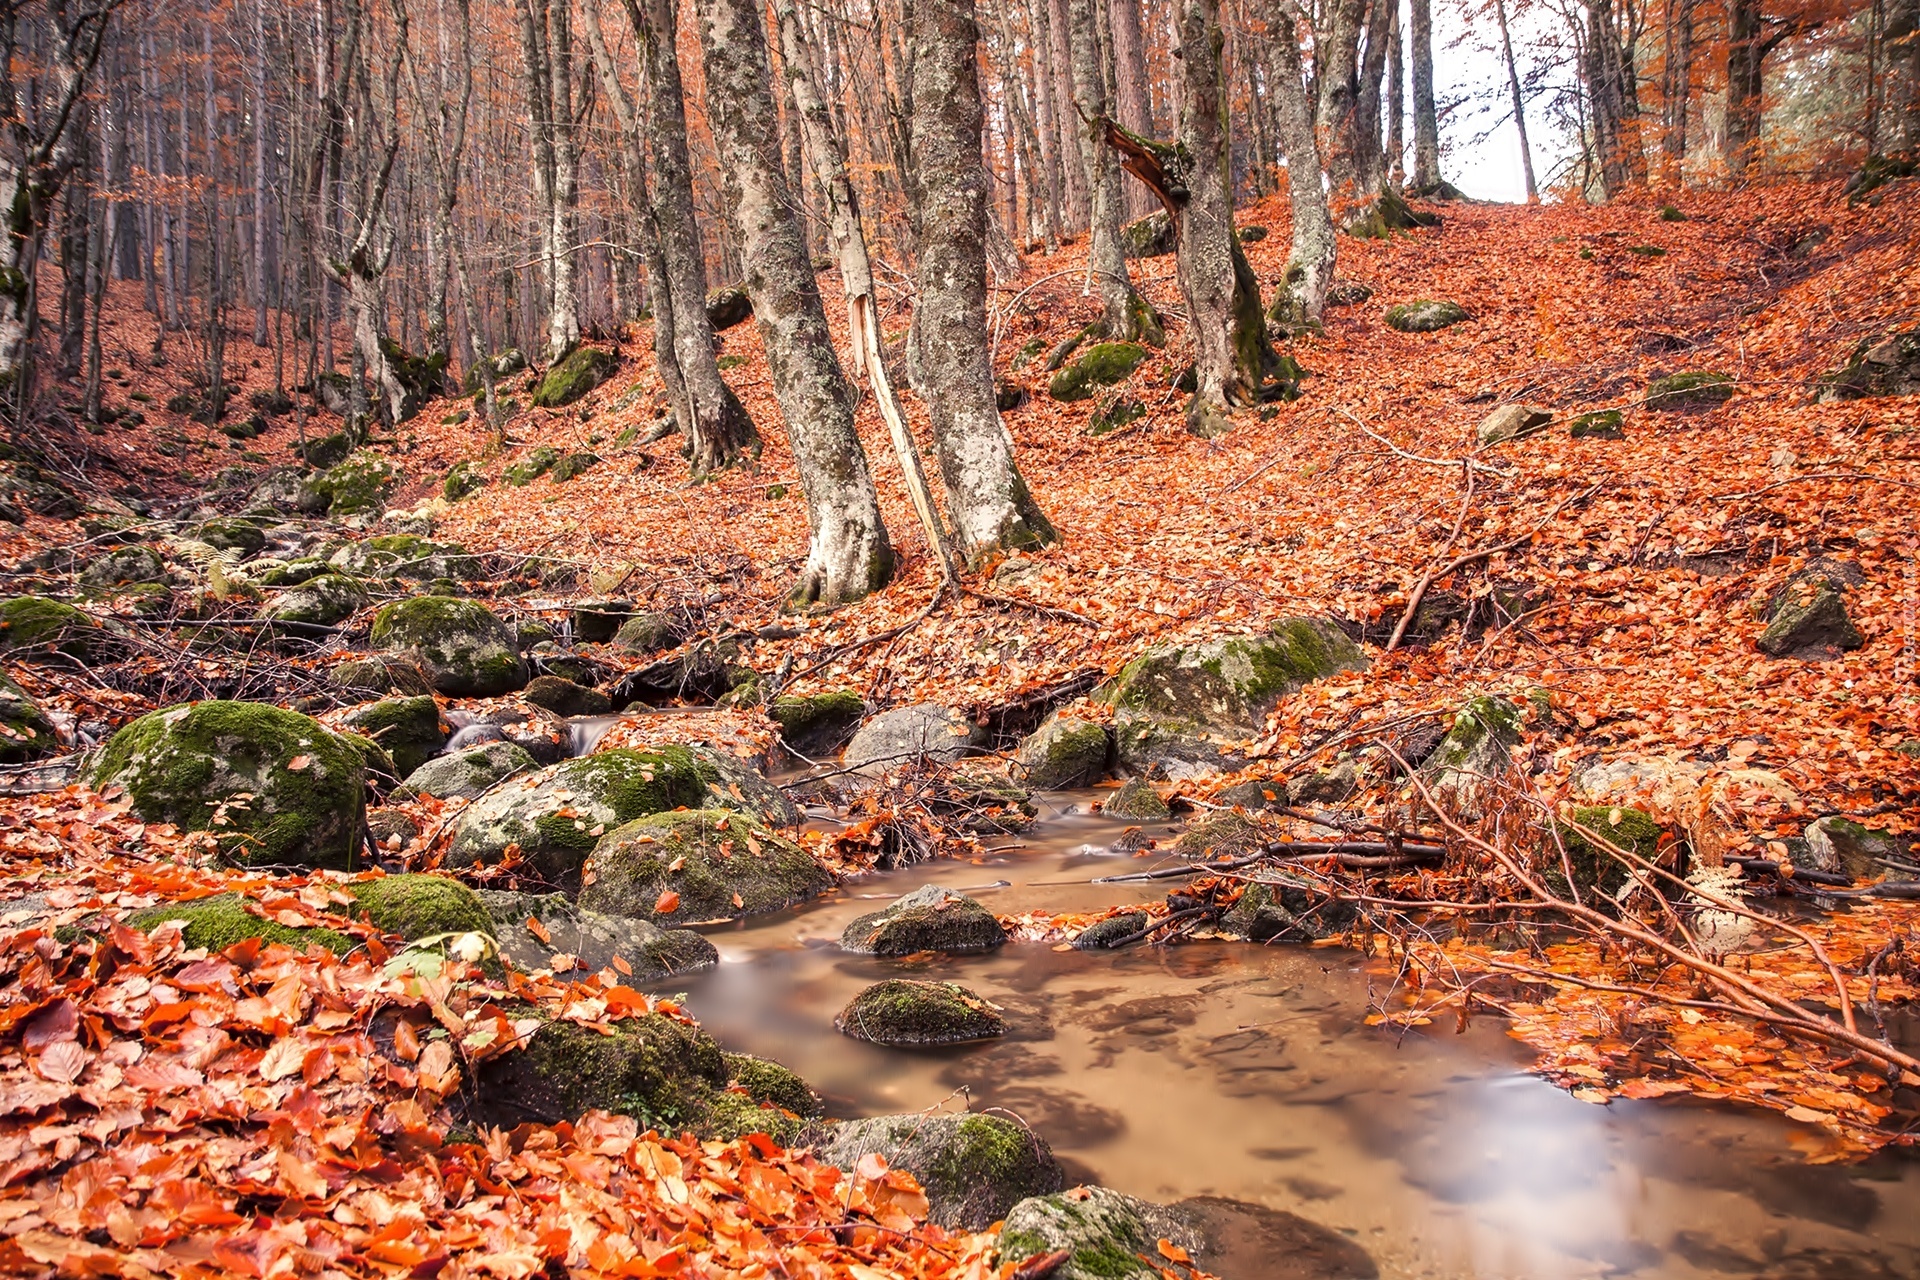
[910,0,1059,562]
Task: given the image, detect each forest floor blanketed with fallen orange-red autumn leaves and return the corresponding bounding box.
[0,172,1920,1276]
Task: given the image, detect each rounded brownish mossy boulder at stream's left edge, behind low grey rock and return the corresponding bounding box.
[580,809,833,923]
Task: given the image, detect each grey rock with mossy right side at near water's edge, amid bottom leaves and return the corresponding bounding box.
[814,1111,1059,1235]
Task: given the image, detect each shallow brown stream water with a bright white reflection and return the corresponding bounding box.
[676,796,1920,1280]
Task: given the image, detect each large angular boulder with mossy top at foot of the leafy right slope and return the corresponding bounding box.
[1104,618,1367,777]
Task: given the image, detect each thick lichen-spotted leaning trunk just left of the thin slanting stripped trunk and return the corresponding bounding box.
[699,0,893,606]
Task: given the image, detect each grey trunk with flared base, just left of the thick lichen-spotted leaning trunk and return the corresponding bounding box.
[624,0,760,476]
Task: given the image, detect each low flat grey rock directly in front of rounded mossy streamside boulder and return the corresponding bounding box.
[480,889,720,981]
